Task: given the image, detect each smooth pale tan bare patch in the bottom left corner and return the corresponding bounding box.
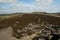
[0,27,18,40]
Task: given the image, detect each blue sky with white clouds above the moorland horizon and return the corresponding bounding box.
[0,0,60,14]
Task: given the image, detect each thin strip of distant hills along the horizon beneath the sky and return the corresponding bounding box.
[0,12,60,16]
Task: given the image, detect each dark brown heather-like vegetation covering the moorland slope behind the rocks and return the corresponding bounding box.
[0,14,60,38]
